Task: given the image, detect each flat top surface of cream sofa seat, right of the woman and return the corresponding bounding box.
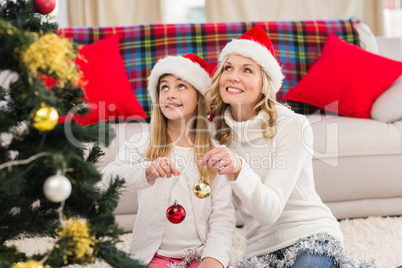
[307,114,402,161]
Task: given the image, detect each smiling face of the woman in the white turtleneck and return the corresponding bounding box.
[219,54,263,109]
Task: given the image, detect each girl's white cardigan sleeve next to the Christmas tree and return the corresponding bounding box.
[101,133,153,192]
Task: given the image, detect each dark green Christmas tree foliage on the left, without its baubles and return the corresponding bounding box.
[0,0,143,268]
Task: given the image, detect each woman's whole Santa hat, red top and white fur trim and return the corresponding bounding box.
[219,26,284,93]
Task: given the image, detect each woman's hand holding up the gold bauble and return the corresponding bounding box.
[200,145,241,180]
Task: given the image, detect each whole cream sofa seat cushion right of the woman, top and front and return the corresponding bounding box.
[308,114,402,202]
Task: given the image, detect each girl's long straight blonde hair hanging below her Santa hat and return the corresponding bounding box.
[146,74,216,183]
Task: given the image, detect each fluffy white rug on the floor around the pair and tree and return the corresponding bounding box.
[6,217,402,268]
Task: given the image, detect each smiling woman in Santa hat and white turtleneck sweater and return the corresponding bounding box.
[201,26,350,267]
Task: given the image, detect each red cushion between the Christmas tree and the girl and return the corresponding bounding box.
[61,35,147,125]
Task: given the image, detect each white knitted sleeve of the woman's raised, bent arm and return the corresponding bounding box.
[230,115,313,225]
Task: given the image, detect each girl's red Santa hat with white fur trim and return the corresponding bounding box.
[148,53,212,103]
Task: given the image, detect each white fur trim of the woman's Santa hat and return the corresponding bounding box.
[219,39,285,93]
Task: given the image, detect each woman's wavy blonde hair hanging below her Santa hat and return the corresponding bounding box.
[205,55,282,145]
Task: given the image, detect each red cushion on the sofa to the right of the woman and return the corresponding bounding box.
[283,33,402,118]
